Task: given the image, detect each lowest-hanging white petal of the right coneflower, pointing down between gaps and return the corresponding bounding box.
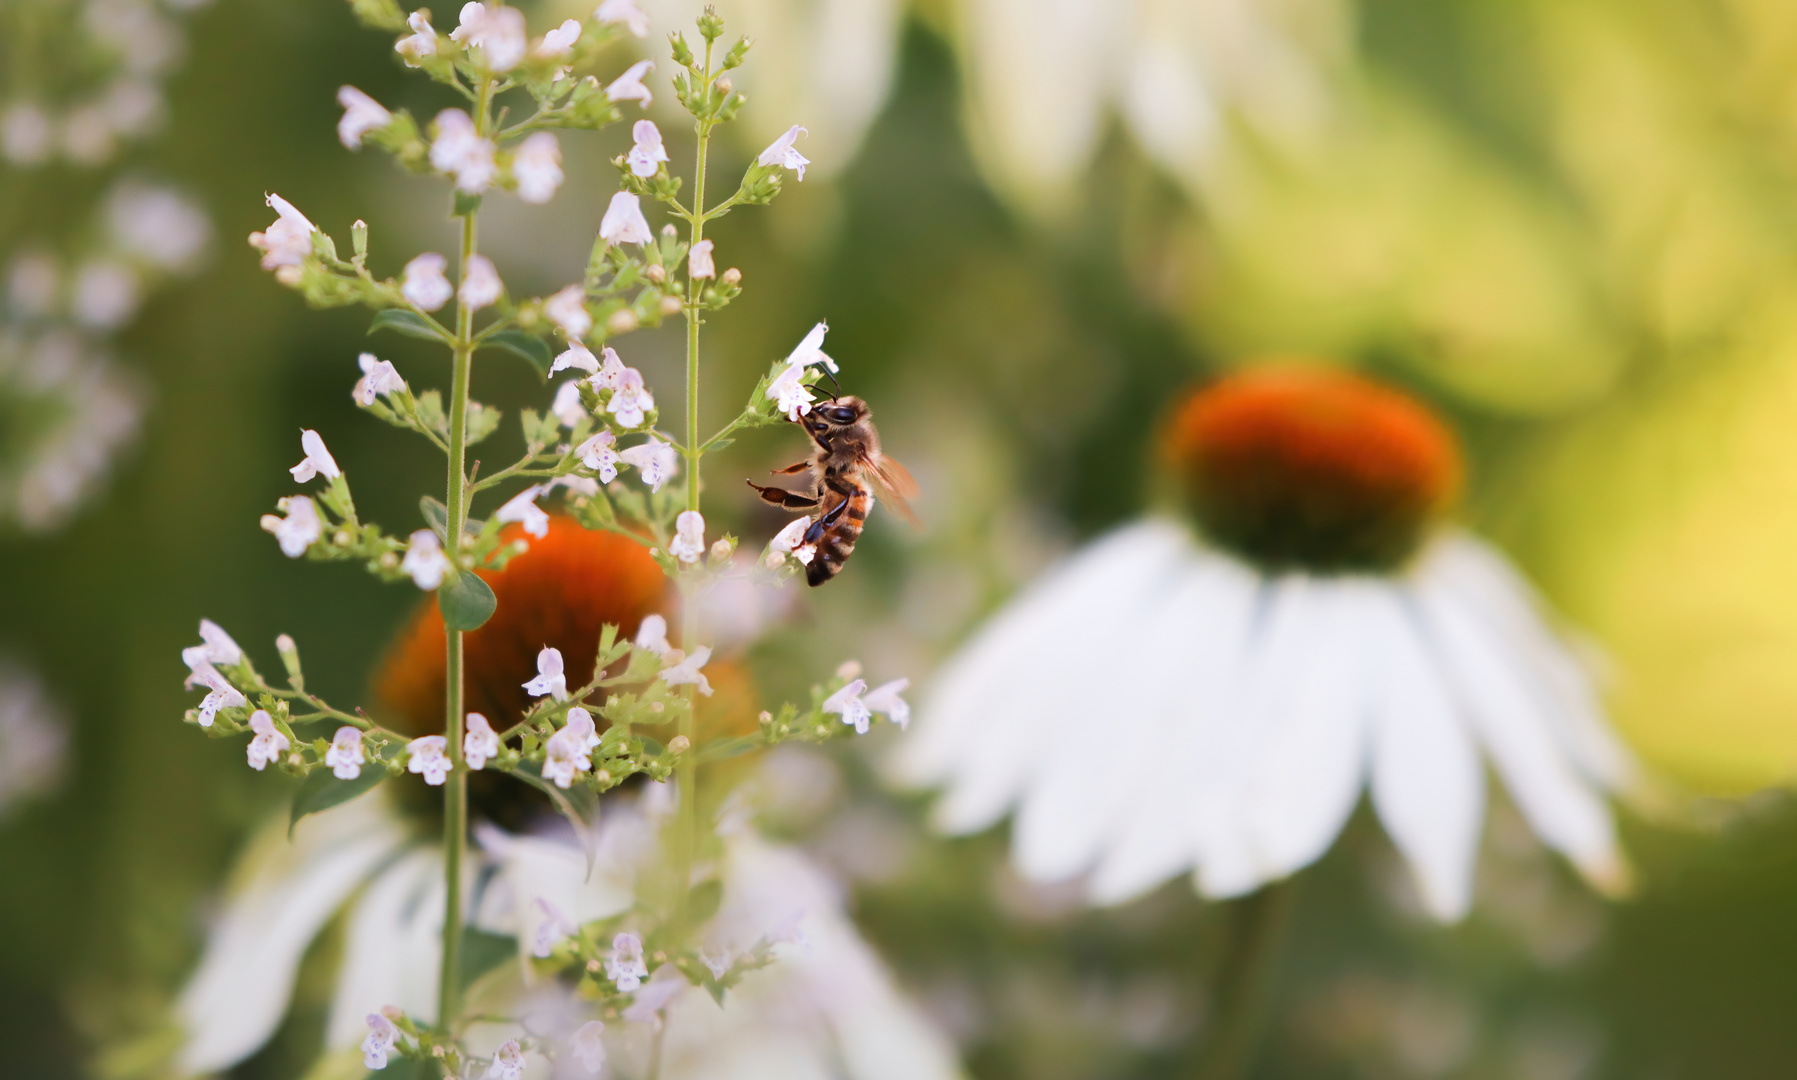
[1364,582,1484,920]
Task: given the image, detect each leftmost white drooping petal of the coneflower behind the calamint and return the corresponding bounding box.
[178,798,404,1073]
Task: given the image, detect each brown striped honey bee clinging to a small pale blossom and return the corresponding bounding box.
[748,395,916,588]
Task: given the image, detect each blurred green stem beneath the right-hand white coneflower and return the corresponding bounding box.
[1195,879,1294,1080]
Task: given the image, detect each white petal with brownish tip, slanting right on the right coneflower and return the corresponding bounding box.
[1416,564,1623,886]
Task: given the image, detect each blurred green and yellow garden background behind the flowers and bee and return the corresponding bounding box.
[14,0,1797,1080]
